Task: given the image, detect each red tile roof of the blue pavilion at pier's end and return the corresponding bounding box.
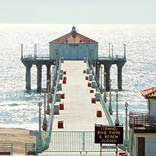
[50,27,97,43]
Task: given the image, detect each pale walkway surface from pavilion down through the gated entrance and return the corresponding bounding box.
[39,61,110,155]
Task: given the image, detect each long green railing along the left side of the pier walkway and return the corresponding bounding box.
[36,61,61,153]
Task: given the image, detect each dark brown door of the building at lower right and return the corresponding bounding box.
[138,137,145,156]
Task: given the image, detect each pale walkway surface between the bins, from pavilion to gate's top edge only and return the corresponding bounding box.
[53,61,108,131]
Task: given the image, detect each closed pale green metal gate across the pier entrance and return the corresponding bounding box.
[46,131,120,152]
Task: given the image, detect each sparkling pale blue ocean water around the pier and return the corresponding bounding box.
[0,24,156,129]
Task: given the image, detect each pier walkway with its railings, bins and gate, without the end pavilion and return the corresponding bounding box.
[22,60,128,156]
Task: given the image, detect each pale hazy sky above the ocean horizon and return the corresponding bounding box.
[0,0,156,24]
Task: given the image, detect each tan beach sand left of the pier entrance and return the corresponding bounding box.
[0,128,36,154]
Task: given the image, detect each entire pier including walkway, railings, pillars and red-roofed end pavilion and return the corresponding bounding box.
[21,27,128,155]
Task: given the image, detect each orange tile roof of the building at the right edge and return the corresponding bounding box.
[141,87,156,98]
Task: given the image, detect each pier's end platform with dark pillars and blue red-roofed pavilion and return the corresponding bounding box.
[21,26,127,92]
